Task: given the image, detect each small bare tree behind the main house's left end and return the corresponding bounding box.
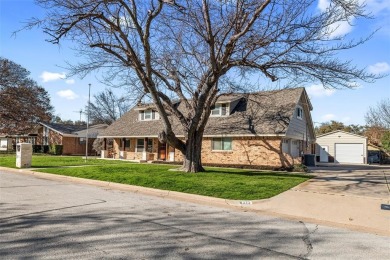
[85,89,135,124]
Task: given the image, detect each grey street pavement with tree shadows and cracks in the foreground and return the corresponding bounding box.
[0,171,390,259]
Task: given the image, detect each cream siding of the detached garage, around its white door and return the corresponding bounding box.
[316,131,367,163]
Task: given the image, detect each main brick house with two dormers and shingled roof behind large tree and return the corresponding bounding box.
[99,88,315,167]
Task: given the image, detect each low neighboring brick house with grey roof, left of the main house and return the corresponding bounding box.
[35,123,108,155]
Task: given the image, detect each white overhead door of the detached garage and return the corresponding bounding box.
[336,144,364,163]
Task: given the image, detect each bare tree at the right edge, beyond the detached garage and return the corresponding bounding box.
[365,98,390,129]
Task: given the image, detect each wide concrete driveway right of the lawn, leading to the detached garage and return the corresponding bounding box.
[250,165,390,235]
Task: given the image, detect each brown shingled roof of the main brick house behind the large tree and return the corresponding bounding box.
[99,88,312,138]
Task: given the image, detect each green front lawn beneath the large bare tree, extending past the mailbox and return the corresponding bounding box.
[0,156,311,200]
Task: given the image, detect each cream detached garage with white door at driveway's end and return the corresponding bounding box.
[316,131,367,164]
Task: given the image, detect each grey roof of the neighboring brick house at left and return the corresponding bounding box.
[40,123,108,138]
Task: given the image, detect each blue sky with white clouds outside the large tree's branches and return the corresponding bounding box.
[0,0,390,124]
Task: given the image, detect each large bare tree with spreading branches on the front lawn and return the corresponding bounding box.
[30,0,375,172]
